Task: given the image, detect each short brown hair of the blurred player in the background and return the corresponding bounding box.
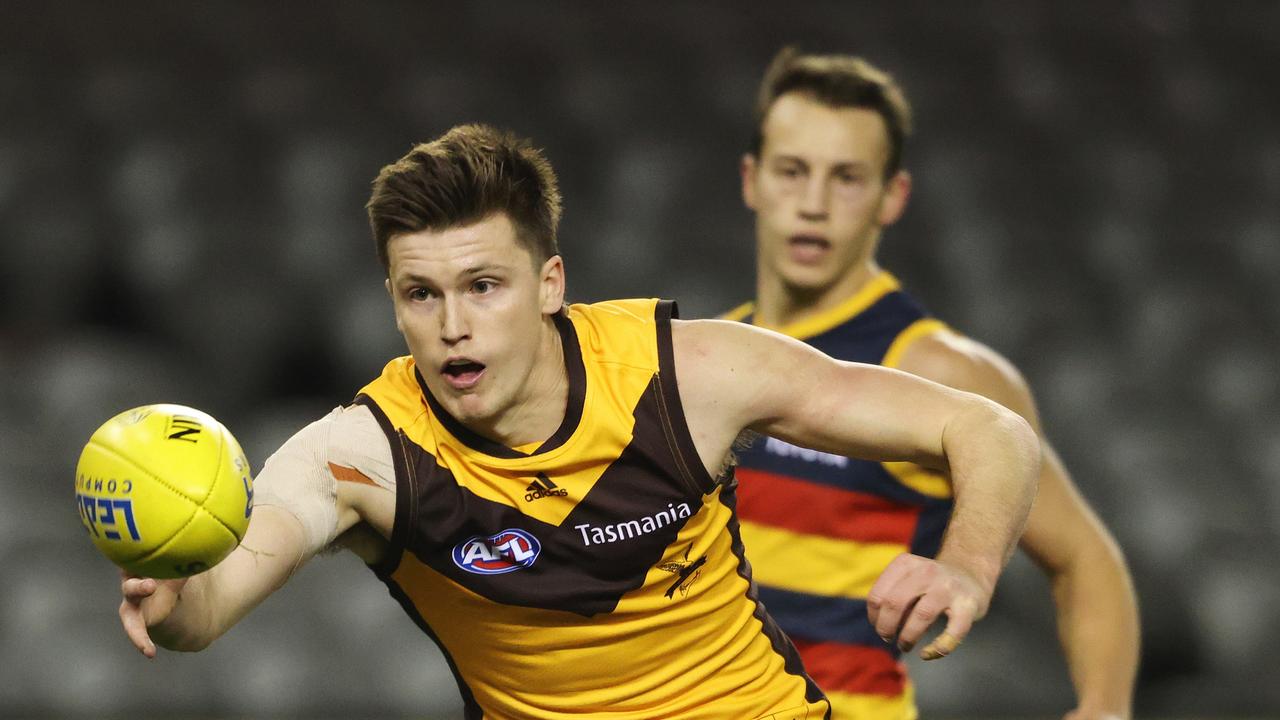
[751,47,911,179]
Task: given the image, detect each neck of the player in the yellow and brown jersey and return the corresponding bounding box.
[472,316,568,447]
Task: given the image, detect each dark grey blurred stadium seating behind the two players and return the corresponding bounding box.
[0,0,1280,717]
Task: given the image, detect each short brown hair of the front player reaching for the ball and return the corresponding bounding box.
[365,124,561,269]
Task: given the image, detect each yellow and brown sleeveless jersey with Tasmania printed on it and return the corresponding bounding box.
[357,300,828,720]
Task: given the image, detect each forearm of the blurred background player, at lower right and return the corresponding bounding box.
[1052,543,1139,717]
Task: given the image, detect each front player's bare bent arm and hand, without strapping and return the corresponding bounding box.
[672,320,1039,657]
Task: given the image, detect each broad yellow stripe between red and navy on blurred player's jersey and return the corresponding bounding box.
[740,520,910,600]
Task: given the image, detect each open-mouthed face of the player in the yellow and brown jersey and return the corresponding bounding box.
[387,213,564,428]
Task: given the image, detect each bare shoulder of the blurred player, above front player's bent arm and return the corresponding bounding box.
[895,328,1034,419]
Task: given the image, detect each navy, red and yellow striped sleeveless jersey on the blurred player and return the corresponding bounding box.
[726,273,951,720]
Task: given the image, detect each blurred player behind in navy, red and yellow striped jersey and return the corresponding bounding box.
[727,50,1138,720]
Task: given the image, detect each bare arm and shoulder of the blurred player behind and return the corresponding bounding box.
[901,332,1139,720]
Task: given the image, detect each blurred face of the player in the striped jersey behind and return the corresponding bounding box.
[742,92,910,292]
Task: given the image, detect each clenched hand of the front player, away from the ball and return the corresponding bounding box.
[867,552,991,660]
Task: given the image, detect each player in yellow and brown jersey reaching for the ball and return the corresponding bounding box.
[120,126,1039,720]
